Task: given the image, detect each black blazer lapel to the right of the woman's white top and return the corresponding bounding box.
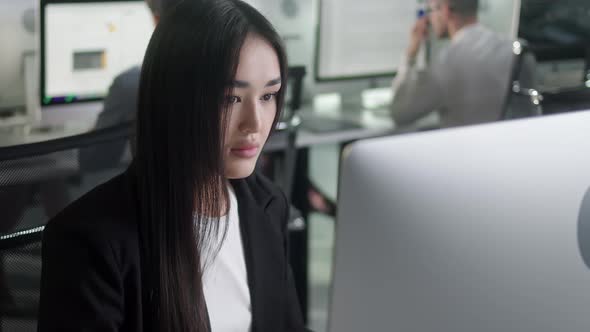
[232,180,286,332]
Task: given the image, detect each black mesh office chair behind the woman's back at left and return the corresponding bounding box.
[0,124,131,331]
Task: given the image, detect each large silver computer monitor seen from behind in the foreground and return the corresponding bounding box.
[329,111,590,332]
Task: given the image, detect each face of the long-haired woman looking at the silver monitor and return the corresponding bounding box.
[223,34,281,179]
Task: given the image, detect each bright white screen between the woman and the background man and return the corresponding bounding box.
[315,0,418,81]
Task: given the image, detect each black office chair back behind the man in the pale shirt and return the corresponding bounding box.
[501,41,543,120]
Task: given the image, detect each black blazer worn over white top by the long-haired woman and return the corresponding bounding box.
[38,168,306,332]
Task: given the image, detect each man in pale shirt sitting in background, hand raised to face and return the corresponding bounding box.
[391,0,534,127]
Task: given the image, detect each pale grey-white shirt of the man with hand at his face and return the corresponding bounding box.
[391,24,534,127]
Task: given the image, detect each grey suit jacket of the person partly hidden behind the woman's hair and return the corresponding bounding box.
[78,66,141,170]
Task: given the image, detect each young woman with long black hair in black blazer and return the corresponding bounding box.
[39,0,305,332]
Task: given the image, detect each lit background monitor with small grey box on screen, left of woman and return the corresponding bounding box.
[41,0,154,106]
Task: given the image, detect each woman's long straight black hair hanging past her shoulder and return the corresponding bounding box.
[135,0,287,332]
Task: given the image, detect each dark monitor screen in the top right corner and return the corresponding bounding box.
[519,0,590,61]
